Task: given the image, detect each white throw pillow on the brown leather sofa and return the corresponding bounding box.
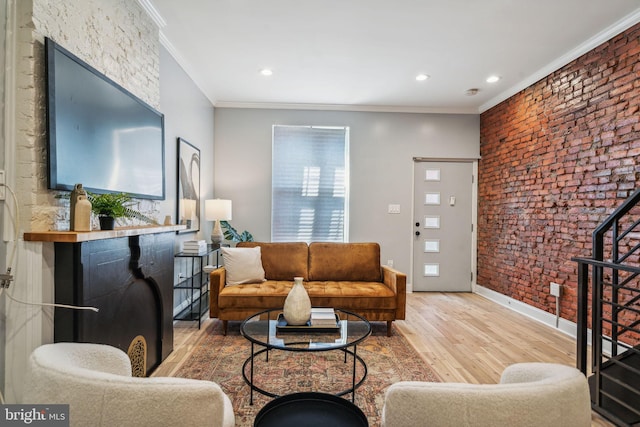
[220,246,265,286]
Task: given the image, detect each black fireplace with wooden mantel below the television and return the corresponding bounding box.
[25,227,181,375]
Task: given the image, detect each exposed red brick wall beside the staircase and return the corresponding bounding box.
[477,24,640,321]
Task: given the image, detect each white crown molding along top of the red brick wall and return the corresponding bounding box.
[477,9,640,113]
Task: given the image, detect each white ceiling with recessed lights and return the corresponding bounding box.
[145,0,640,114]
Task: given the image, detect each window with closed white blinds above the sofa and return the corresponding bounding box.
[271,125,349,242]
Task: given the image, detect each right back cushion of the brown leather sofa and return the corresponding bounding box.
[308,242,382,282]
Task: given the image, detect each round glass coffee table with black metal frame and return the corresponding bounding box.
[240,309,371,404]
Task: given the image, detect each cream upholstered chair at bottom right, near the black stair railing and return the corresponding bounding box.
[382,363,591,427]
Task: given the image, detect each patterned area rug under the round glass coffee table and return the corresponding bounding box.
[175,321,440,427]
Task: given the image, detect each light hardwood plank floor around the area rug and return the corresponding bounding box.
[154,292,613,427]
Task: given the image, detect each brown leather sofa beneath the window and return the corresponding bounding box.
[209,242,407,335]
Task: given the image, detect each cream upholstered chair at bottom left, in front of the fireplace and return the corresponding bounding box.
[22,343,235,427]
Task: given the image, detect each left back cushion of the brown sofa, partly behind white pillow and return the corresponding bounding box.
[236,242,309,282]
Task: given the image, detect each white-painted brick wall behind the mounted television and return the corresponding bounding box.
[15,0,160,231]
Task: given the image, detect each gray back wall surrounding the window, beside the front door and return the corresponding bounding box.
[214,108,480,273]
